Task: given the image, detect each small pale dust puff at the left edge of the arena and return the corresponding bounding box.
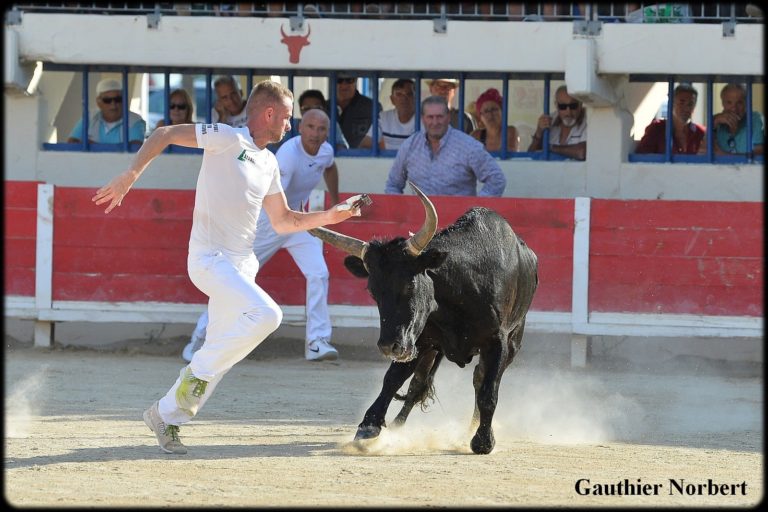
[5,365,48,438]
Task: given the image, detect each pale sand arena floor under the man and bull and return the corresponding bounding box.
[4,347,764,507]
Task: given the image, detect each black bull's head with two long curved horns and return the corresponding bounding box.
[309,182,447,362]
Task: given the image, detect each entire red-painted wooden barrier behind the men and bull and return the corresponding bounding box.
[10,182,764,317]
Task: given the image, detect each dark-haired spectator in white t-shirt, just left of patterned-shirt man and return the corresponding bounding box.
[360,78,416,149]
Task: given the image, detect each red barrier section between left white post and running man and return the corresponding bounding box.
[53,187,206,303]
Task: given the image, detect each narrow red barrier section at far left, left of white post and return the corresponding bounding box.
[3,181,38,297]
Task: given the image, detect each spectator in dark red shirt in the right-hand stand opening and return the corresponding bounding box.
[635,84,707,155]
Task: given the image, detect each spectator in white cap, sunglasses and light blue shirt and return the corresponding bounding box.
[67,78,147,144]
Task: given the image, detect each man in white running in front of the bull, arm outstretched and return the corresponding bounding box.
[92,80,360,454]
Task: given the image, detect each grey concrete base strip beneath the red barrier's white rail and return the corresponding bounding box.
[5,318,764,375]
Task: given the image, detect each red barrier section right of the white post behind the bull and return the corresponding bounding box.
[589,199,764,316]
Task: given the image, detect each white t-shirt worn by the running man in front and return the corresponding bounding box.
[189,123,283,264]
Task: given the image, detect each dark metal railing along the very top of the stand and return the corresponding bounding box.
[6,2,763,23]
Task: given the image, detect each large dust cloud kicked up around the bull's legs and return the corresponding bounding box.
[342,365,647,455]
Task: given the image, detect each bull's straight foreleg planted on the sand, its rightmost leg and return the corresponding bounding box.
[470,340,507,454]
